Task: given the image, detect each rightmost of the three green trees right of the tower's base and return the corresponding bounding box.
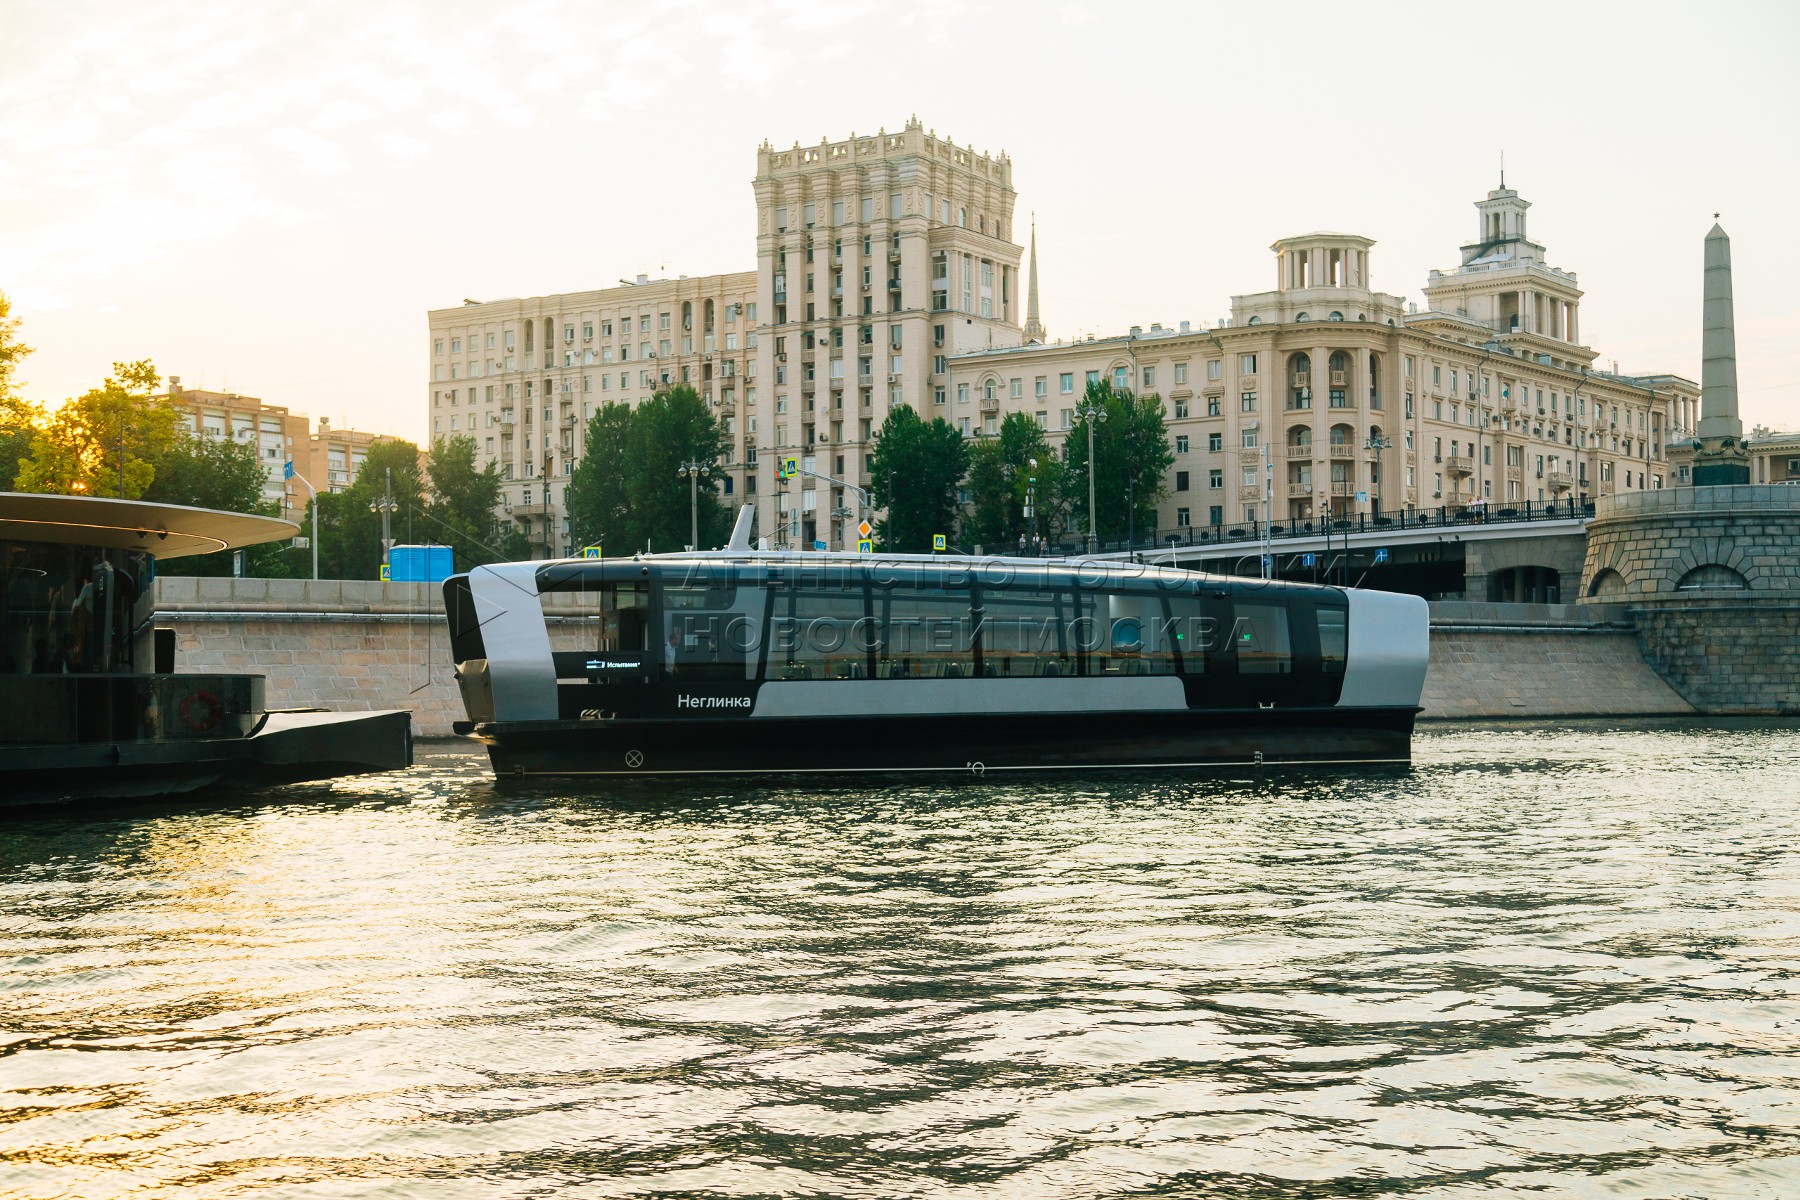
[1062,380,1175,542]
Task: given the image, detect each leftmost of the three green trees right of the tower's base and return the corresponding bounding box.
[869,405,968,552]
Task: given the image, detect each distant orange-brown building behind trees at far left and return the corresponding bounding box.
[155,374,394,522]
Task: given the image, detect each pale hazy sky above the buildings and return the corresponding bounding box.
[0,0,1800,439]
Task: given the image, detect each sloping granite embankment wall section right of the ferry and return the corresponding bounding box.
[1424,601,1694,720]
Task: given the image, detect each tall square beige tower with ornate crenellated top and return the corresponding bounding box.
[745,117,1022,549]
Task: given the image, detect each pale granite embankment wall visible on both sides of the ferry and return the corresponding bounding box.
[157,576,1692,738]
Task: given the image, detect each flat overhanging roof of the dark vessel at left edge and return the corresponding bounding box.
[0,491,301,558]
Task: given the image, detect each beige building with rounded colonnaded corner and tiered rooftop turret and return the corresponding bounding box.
[940,187,1699,534]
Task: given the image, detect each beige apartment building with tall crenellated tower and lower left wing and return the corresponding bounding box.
[428,119,1022,554]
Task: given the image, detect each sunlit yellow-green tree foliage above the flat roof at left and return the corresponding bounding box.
[16,360,180,500]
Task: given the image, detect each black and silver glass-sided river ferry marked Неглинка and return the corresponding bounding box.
[445,510,1427,777]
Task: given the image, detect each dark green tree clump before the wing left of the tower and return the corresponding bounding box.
[565,385,731,554]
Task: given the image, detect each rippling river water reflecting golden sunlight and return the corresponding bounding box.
[0,721,1800,1198]
